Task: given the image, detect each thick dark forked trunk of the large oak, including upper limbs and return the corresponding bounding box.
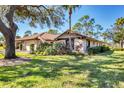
[0,5,18,59]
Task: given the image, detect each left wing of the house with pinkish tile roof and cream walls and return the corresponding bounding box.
[15,32,58,52]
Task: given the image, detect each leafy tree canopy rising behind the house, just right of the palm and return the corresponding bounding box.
[73,15,103,39]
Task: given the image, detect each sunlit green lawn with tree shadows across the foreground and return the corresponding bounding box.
[0,52,124,88]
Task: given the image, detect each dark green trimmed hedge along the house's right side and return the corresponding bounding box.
[88,46,110,55]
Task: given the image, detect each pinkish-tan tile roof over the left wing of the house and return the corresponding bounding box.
[16,32,58,41]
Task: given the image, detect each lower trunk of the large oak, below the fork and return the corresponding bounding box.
[5,31,17,59]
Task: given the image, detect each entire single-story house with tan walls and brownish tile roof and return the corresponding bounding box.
[16,30,109,53]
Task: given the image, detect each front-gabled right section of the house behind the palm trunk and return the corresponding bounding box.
[55,30,109,53]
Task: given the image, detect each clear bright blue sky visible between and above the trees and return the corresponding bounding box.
[17,5,124,36]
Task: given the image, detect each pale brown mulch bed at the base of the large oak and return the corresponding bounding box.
[0,58,32,66]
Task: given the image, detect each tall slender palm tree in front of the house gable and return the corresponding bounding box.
[63,5,80,51]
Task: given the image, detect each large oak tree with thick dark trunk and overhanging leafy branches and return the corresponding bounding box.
[0,5,64,59]
